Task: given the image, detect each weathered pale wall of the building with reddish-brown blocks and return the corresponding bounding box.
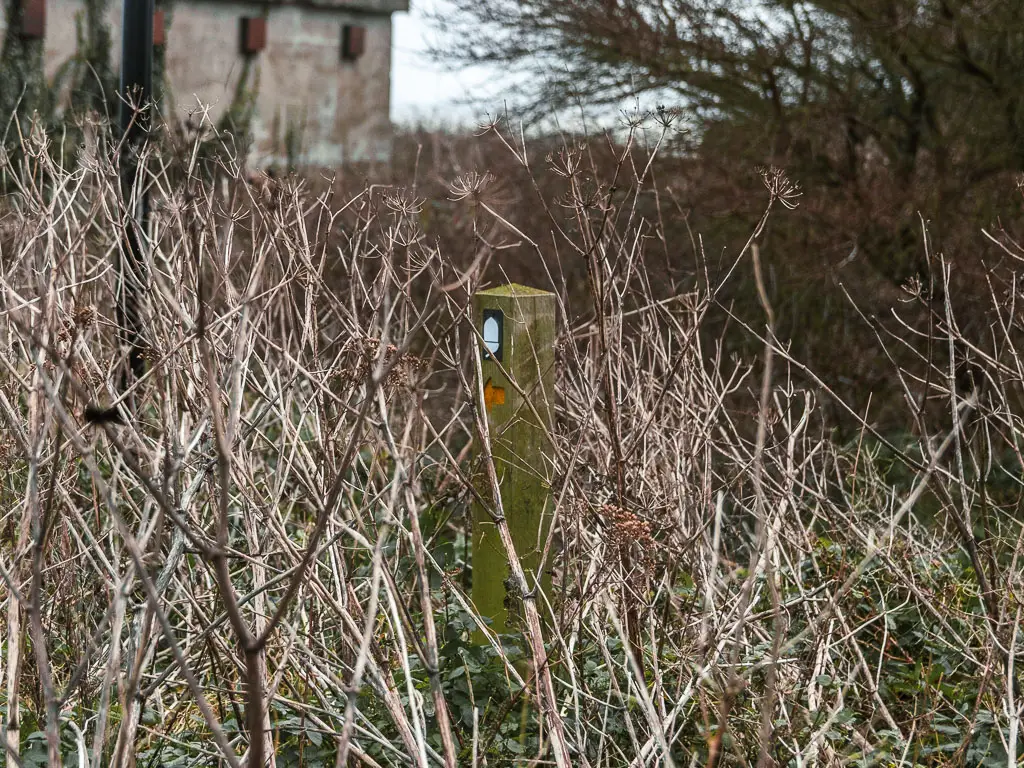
[0,0,408,167]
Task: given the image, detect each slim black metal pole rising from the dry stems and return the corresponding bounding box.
[118,0,154,384]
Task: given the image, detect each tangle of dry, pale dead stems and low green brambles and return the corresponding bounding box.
[0,109,1024,768]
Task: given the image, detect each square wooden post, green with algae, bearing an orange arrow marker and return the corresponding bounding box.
[473,284,555,642]
